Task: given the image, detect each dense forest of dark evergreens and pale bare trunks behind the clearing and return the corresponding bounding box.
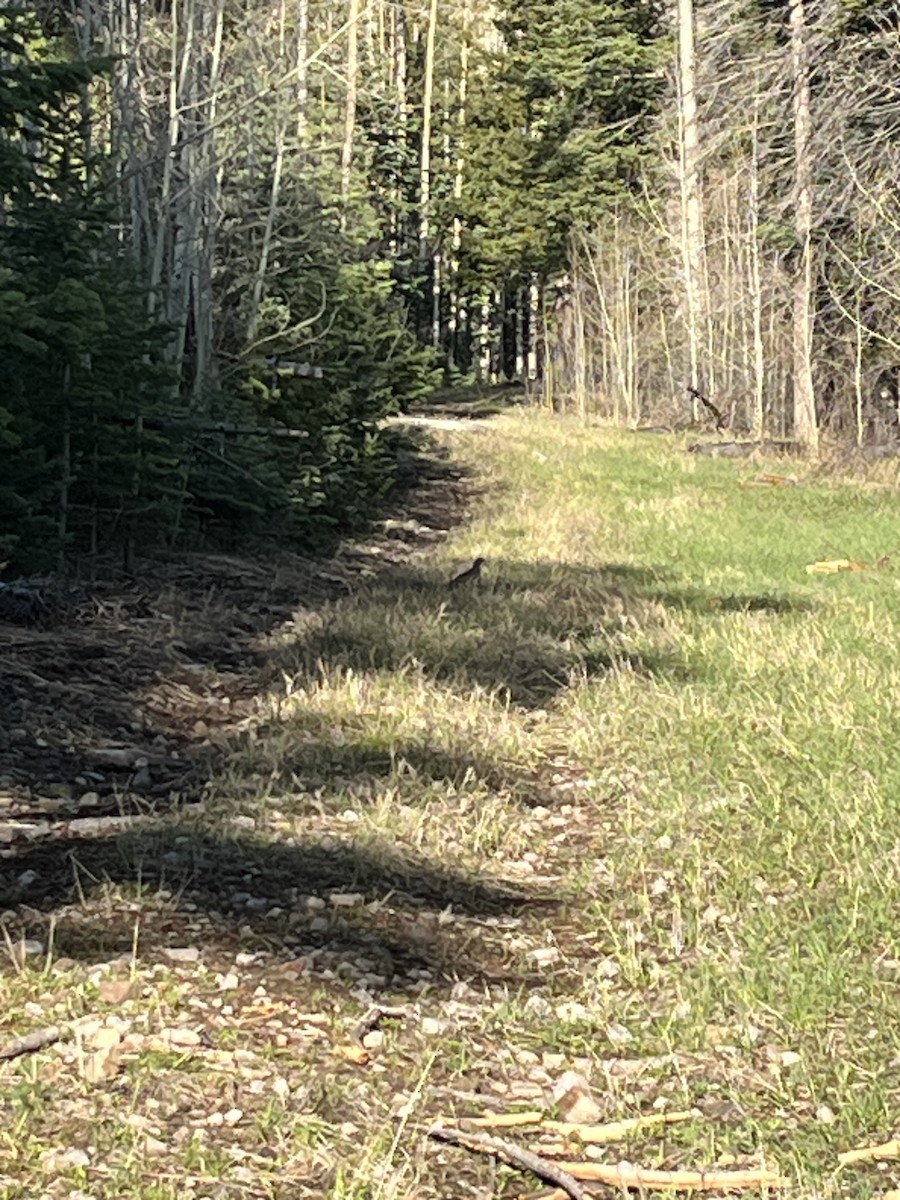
[0,0,900,571]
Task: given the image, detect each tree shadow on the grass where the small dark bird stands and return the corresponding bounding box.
[267,562,806,708]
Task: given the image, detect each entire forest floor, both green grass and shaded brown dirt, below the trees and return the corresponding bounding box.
[0,413,900,1200]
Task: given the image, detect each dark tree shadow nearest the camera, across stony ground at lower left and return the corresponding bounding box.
[0,823,558,991]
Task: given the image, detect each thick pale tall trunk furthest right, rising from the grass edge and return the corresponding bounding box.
[790,0,818,455]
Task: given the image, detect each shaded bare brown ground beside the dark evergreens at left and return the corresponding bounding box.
[0,446,472,830]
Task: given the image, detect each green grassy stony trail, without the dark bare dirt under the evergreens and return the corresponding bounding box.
[0,414,900,1200]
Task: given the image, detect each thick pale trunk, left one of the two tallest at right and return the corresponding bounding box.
[678,0,704,420]
